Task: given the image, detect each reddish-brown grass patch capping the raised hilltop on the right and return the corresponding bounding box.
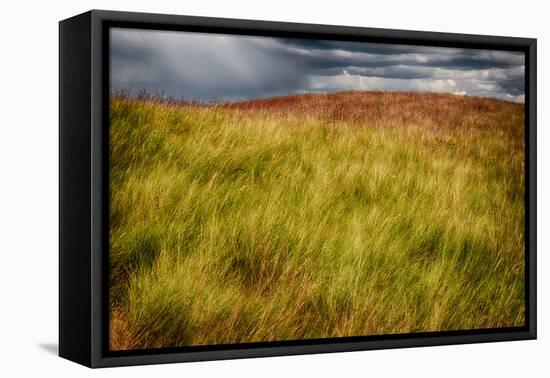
[222,91,523,129]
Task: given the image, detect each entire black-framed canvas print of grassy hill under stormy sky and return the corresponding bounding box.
[59,10,536,367]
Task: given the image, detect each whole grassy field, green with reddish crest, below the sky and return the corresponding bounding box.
[110,92,525,350]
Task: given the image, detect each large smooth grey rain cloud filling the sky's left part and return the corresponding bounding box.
[111,30,307,100]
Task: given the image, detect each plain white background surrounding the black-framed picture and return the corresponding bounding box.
[0,0,550,378]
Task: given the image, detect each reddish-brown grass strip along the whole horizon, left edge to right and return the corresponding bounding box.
[113,91,524,132]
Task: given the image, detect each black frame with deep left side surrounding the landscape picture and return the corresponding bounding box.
[59,10,537,368]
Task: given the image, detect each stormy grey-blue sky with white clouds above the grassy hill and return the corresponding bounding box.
[111,28,525,102]
